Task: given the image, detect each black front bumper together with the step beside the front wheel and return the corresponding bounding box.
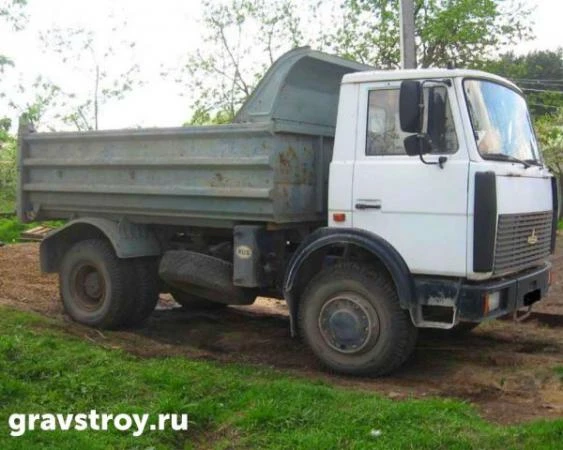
[411,262,551,328]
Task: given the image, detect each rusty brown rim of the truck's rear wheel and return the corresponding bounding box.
[70,263,106,311]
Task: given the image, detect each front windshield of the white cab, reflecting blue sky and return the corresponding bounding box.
[463,79,539,161]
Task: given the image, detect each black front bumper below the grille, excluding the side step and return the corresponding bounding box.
[458,263,551,322]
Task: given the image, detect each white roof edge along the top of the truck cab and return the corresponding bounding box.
[342,69,521,92]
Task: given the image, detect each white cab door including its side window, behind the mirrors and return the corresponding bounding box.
[352,81,469,277]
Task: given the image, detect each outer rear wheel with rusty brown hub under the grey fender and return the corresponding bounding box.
[59,239,131,329]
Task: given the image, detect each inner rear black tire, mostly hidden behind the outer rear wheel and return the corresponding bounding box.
[124,258,160,326]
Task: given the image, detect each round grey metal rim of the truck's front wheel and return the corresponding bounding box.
[319,293,379,354]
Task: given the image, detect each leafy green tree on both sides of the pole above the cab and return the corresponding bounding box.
[331,0,530,69]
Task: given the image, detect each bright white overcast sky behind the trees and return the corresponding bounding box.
[0,0,563,128]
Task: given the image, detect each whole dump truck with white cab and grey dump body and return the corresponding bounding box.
[18,48,558,375]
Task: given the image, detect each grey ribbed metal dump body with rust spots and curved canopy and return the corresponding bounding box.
[18,48,368,228]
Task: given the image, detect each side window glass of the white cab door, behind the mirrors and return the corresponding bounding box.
[366,86,458,156]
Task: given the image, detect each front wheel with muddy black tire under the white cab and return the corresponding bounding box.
[299,262,418,376]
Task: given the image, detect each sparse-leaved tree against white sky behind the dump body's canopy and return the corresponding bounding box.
[180,0,303,124]
